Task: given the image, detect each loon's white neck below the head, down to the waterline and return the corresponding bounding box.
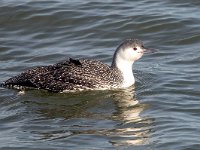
[111,56,135,87]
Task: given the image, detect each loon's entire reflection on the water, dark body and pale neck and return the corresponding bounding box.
[22,86,151,146]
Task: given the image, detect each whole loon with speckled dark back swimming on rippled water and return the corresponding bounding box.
[2,38,149,93]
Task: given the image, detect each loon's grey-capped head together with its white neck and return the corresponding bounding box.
[112,39,148,87]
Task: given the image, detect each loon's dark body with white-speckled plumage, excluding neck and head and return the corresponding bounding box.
[4,58,122,92]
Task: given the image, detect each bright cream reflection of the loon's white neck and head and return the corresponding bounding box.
[107,89,151,145]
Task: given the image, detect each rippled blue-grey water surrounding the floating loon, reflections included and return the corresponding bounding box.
[0,0,200,150]
